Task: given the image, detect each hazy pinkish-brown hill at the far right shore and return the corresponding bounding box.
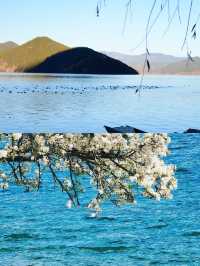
[160,57,200,75]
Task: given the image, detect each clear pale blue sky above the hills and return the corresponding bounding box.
[0,0,200,56]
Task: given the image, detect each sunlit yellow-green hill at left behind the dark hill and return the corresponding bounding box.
[0,37,69,72]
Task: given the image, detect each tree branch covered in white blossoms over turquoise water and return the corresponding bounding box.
[0,133,176,212]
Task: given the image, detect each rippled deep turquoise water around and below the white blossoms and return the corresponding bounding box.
[0,134,200,266]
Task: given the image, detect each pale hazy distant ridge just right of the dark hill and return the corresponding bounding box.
[103,52,184,74]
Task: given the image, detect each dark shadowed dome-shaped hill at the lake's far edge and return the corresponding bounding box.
[29,47,138,75]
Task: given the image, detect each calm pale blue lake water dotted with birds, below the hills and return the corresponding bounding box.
[0,74,200,132]
